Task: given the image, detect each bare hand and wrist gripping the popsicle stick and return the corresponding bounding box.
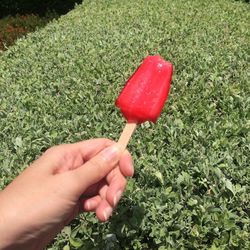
[0,139,133,250]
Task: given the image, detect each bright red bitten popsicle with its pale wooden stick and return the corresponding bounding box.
[115,55,173,149]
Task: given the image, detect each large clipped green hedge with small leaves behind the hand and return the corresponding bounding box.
[0,0,250,250]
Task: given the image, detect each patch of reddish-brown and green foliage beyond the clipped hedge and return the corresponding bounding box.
[0,12,58,50]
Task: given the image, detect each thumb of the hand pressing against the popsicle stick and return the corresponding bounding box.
[71,144,122,194]
